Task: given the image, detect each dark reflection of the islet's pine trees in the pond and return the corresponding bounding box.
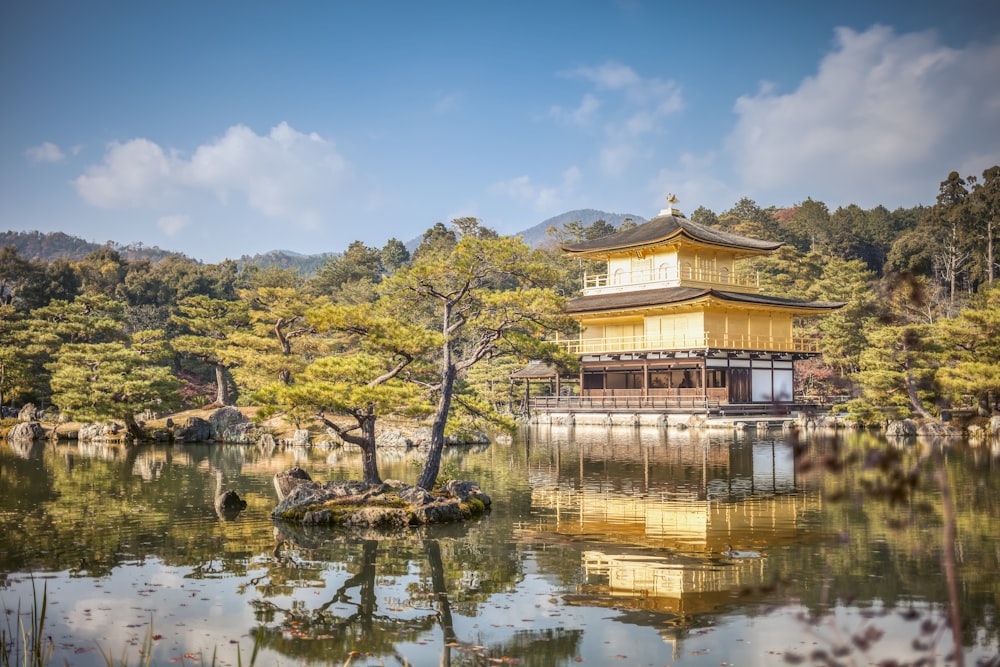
[251,524,583,665]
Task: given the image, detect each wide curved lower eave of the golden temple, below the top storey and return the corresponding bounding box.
[566,287,844,315]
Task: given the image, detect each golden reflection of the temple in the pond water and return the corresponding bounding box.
[519,427,822,616]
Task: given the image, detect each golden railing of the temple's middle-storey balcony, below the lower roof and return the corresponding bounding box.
[550,334,819,354]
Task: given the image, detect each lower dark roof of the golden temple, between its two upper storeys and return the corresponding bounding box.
[566,287,844,313]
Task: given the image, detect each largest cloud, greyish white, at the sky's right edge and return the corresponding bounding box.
[726,26,1000,206]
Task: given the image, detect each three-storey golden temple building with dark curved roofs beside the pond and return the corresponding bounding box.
[558,196,844,409]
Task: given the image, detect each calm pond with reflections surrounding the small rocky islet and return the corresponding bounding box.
[0,426,1000,667]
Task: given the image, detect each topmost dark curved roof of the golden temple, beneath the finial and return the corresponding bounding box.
[562,215,784,254]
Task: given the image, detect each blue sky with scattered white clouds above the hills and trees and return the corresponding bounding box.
[0,0,1000,262]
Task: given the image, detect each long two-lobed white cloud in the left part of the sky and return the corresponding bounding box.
[75,123,352,229]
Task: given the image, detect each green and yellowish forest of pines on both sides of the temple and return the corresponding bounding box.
[0,166,1000,444]
